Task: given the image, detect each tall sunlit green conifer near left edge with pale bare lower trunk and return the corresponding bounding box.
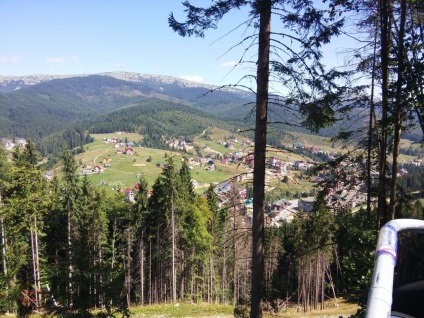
[2,141,50,309]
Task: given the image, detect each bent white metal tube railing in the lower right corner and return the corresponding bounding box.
[365,219,424,318]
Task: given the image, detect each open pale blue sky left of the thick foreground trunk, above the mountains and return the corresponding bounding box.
[0,0,354,85]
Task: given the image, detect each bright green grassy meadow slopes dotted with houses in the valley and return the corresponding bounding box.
[63,128,314,193]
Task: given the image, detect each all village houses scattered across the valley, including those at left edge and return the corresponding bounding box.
[0,136,423,227]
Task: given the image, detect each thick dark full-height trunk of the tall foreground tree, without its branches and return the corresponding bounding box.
[250,0,271,318]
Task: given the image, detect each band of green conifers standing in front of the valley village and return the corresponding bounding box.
[0,141,424,316]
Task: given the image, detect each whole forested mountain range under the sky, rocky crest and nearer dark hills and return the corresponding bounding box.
[0,72,390,158]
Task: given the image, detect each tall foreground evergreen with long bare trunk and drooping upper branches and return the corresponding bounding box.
[169,0,352,317]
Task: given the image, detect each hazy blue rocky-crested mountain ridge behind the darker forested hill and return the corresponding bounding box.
[0,72,254,140]
